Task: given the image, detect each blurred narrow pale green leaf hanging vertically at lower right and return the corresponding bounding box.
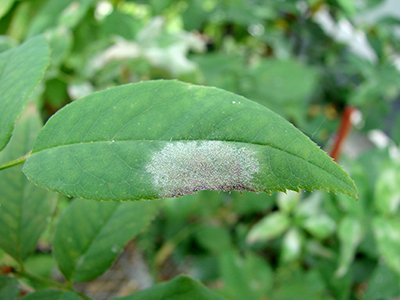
[336,216,364,277]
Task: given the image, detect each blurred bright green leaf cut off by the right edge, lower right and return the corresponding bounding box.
[372,217,400,274]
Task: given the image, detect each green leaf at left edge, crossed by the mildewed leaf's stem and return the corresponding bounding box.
[0,104,55,262]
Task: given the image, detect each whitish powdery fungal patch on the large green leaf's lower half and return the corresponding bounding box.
[146,141,259,197]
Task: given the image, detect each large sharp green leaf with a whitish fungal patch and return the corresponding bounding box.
[24,81,357,201]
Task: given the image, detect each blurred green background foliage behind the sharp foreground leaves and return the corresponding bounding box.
[0,0,400,300]
